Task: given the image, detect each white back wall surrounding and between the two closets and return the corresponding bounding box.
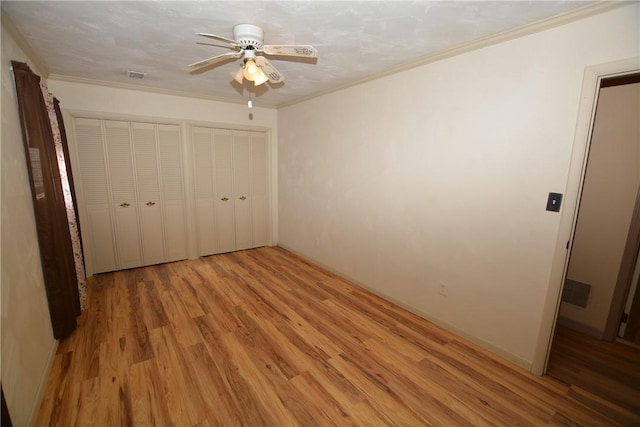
[48,79,278,273]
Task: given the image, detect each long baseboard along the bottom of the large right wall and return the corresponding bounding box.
[277,243,533,372]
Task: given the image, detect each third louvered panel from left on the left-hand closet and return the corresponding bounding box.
[131,123,165,265]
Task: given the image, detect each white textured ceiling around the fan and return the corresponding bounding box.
[1,0,587,106]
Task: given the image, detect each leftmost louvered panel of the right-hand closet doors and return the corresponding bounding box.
[191,127,217,256]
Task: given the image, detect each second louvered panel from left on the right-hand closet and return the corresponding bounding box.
[213,129,237,253]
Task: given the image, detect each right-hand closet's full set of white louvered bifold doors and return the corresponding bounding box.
[192,127,268,255]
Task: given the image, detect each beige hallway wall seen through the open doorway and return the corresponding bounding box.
[560,83,640,332]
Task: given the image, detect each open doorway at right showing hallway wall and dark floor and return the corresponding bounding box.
[546,69,640,412]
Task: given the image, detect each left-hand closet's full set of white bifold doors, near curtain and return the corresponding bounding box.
[74,118,187,274]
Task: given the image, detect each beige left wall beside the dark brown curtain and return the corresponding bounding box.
[0,18,57,426]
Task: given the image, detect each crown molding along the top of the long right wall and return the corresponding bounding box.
[277,0,638,109]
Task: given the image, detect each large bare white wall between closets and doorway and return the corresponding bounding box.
[278,3,640,367]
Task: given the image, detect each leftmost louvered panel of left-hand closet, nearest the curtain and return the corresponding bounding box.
[74,118,117,273]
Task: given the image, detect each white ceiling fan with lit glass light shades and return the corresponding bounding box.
[189,24,318,86]
